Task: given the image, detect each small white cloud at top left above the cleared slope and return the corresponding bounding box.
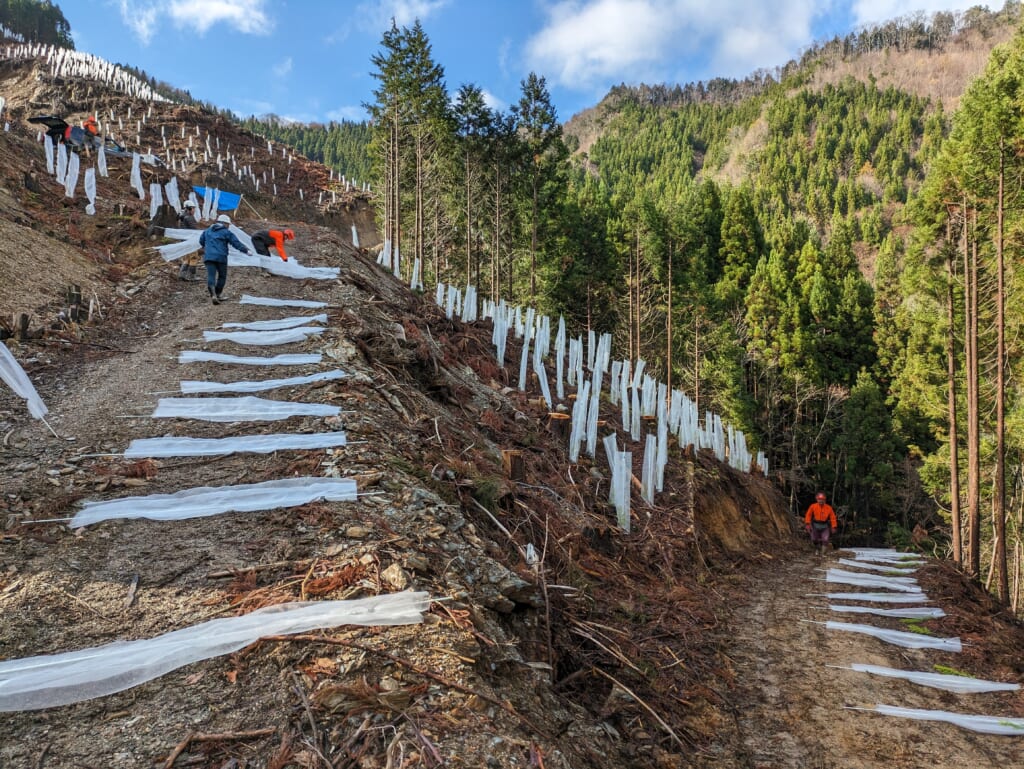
[118,0,273,45]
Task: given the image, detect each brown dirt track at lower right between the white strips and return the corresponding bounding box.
[727,553,1024,769]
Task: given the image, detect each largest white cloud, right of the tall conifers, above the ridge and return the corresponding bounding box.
[525,0,833,89]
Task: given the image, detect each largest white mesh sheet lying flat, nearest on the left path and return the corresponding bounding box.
[0,591,430,713]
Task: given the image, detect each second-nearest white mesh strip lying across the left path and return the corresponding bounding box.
[70,477,355,528]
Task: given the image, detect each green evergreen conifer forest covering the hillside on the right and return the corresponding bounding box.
[276,3,1024,602]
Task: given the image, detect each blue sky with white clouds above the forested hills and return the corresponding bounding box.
[57,0,1002,122]
